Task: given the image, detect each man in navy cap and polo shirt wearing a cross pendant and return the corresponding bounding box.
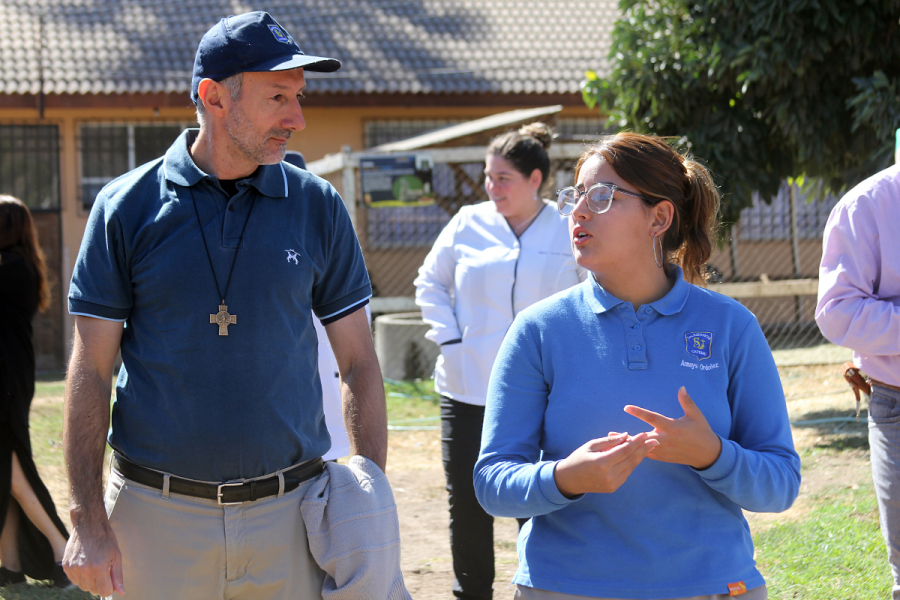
[64,12,390,600]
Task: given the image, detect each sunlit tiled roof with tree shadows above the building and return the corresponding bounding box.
[0,0,618,94]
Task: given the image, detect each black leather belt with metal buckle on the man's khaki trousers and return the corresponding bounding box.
[112,454,325,506]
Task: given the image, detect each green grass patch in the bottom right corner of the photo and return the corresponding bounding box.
[754,485,892,600]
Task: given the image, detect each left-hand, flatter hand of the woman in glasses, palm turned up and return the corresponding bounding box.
[553,433,659,498]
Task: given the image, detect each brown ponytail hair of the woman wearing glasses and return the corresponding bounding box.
[575,132,720,284]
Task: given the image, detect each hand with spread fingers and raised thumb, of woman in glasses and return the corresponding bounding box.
[625,386,722,470]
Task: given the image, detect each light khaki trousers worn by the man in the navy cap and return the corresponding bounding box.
[105,470,325,600]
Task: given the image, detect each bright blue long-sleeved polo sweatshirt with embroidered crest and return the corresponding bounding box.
[475,267,800,599]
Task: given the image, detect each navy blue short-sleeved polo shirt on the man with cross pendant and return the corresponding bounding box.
[69,130,371,481]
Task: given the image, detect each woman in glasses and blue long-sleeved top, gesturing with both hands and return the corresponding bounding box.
[475,133,800,600]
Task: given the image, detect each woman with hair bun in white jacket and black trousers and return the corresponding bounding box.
[415,123,583,600]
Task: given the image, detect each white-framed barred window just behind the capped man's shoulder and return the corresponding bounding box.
[80,123,195,210]
